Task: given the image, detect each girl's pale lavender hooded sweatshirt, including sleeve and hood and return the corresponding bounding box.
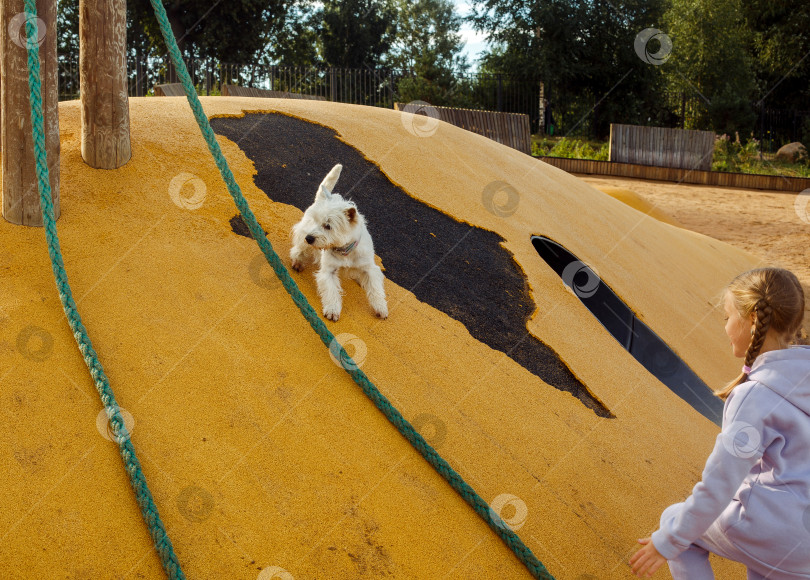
[652,346,810,578]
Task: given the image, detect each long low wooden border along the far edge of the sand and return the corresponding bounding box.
[538,157,810,193]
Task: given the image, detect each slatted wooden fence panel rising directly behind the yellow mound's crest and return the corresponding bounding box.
[394,103,532,155]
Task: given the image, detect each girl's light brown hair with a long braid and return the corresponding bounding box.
[714,268,804,400]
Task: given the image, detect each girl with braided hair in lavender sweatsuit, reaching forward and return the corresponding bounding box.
[630,268,810,580]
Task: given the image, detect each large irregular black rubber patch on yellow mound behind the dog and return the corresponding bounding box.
[211,114,613,417]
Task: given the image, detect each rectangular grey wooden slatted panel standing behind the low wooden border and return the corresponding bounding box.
[609,123,714,171]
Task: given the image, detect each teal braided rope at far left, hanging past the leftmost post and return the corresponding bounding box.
[25,5,185,580]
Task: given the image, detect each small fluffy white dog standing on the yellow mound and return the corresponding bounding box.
[290,165,388,321]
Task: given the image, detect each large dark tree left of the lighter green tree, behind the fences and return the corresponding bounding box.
[471,0,673,136]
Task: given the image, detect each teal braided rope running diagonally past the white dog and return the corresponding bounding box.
[150,0,553,580]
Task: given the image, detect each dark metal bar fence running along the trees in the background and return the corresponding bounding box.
[59,56,810,151]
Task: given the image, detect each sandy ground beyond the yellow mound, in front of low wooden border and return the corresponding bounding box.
[578,175,810,331]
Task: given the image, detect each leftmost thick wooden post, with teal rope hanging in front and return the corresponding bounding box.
[0,0,60,226]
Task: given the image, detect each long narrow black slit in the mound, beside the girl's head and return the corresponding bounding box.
[532,236,723,425]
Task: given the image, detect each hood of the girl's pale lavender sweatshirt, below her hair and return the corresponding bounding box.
[748,345,810,415]
